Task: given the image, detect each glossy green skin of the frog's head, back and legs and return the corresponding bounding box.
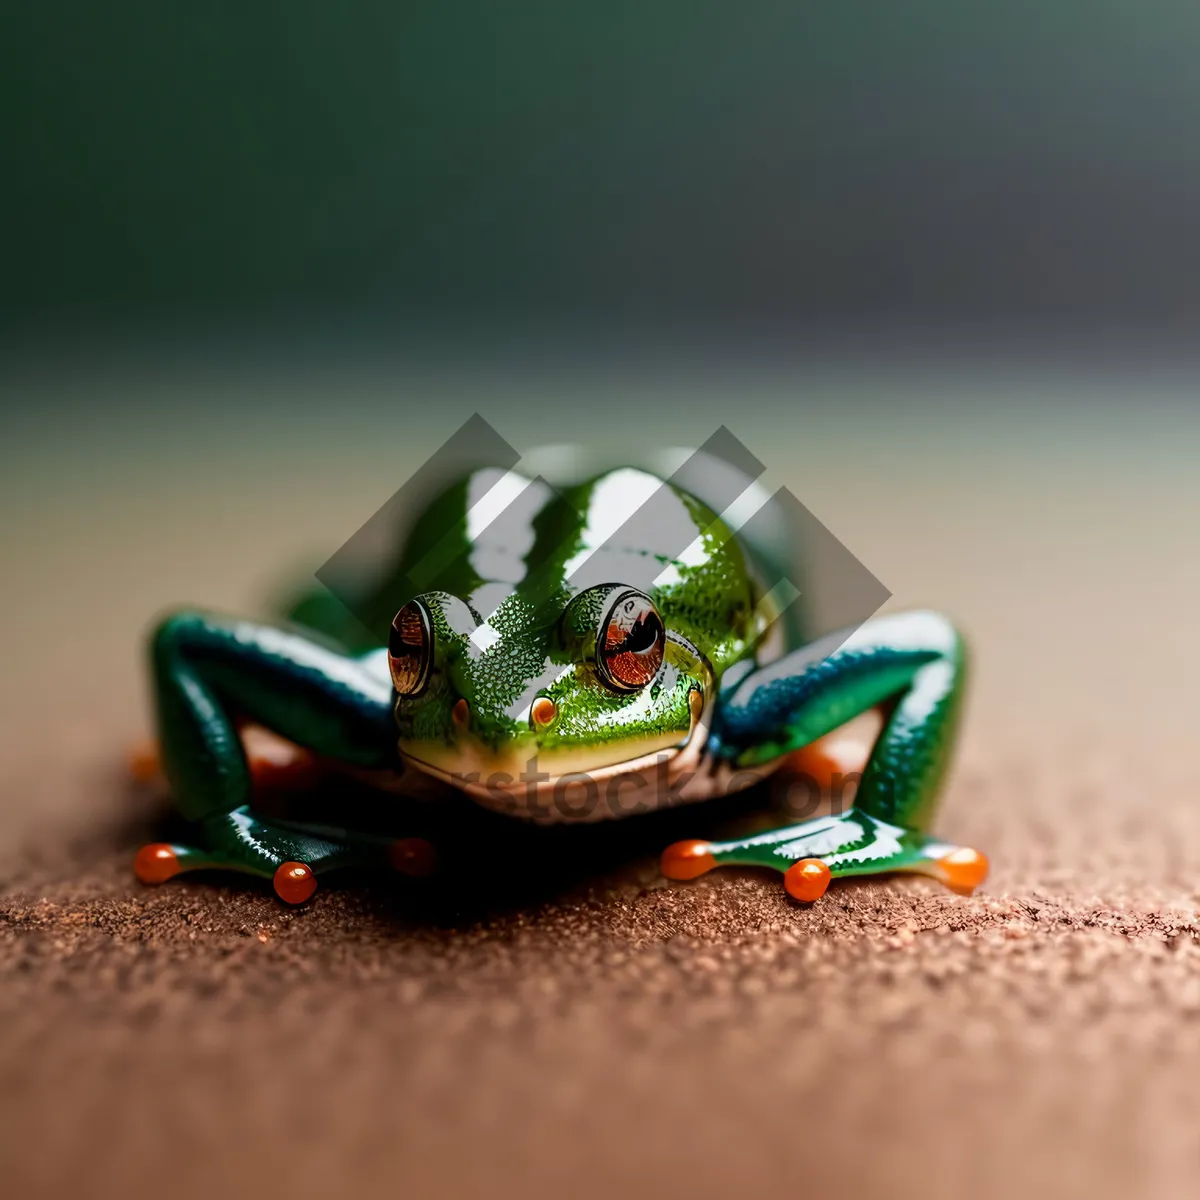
[151,473,979,902]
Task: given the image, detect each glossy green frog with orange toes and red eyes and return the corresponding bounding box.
[134,451,988,905]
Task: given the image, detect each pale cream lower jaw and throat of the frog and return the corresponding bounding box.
[401,686,715,823]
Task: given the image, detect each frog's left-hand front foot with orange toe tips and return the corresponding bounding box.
[133,808,437,904]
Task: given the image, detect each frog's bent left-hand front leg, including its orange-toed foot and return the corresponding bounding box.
[134,612,410,904]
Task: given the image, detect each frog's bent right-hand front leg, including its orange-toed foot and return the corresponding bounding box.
[662,612,988,900]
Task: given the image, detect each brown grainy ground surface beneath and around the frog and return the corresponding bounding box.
[0,379,1200,1200]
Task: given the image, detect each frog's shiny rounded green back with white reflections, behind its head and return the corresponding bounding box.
[290,456,777,672]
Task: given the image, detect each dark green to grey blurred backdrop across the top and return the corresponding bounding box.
[7,0,1200,336]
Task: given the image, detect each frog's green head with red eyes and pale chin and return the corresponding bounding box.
[388,583,713,818]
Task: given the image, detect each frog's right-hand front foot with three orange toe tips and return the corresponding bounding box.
[662,809,988,902]
